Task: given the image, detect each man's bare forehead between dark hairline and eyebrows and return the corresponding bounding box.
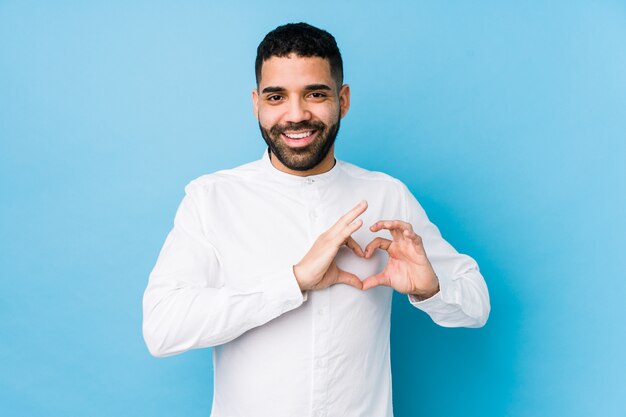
[259,54,335,90]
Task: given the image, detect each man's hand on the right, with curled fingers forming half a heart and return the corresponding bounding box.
[363,220,439,299]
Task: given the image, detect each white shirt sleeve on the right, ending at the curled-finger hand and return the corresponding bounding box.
[404,187,490,327]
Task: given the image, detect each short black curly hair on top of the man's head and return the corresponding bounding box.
[254,23,343,86]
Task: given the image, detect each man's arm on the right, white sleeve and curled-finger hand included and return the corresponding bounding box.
[363,185,490,327]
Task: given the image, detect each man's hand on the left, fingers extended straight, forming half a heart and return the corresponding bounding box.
[293,201,367,291]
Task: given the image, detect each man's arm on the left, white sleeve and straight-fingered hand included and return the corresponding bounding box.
[143,187,367,356]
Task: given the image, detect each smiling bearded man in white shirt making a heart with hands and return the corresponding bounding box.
[143,23,489,417]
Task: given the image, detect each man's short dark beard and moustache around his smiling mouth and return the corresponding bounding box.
[259,118,340,171]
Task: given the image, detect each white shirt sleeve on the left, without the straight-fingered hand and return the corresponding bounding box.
[143,186,305,356]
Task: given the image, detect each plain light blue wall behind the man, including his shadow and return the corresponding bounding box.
[0,1,626,417]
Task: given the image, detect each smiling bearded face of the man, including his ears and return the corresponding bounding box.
[252,54,350,175]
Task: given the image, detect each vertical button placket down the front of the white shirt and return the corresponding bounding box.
[304,177,330,417]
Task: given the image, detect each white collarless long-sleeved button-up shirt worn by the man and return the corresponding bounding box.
[143,152,490,417]
